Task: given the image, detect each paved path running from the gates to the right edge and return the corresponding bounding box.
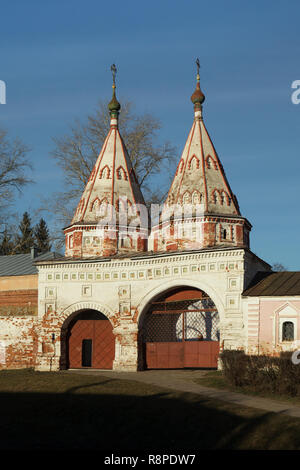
[69,369,300,418]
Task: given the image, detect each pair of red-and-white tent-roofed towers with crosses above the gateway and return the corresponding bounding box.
[65,62,251,258]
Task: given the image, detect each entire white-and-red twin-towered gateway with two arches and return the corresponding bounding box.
[0,63,277,371]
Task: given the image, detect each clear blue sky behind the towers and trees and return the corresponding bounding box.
[0,0,300,270]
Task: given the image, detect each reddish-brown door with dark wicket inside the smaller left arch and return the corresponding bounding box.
[68,318,115,369]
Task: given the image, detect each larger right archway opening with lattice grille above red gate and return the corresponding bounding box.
[139,286,220,369]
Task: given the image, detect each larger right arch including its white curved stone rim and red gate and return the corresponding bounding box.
[136,279,224,370]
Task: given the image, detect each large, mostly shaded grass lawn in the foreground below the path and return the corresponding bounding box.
[0,370,300,452]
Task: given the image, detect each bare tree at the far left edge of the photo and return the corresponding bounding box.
[0,129,32,222]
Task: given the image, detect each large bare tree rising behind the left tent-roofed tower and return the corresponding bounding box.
[48,101,177,233]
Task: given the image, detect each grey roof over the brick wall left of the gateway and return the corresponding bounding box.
[0,251,63,276]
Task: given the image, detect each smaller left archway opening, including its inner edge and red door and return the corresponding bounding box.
[61,309,115,369]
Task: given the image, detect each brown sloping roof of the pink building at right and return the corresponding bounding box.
[243,271,300,297]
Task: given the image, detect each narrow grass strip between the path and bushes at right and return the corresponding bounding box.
[194,370,300,405]
